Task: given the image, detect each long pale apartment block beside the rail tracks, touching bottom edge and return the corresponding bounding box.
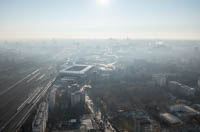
[32,102,48,132]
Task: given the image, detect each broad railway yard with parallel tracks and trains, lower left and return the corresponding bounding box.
[0,64,56,132]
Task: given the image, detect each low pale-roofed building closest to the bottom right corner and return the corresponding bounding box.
[160,113,182,126]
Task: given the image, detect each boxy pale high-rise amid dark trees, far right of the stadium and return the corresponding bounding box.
[152,74,167,87]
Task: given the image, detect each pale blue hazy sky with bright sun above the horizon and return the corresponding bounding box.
[0,0,200,39]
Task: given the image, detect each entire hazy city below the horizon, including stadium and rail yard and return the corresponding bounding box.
[0,39,200,132]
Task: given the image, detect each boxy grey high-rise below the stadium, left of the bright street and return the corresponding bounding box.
[71,91,85,106]
